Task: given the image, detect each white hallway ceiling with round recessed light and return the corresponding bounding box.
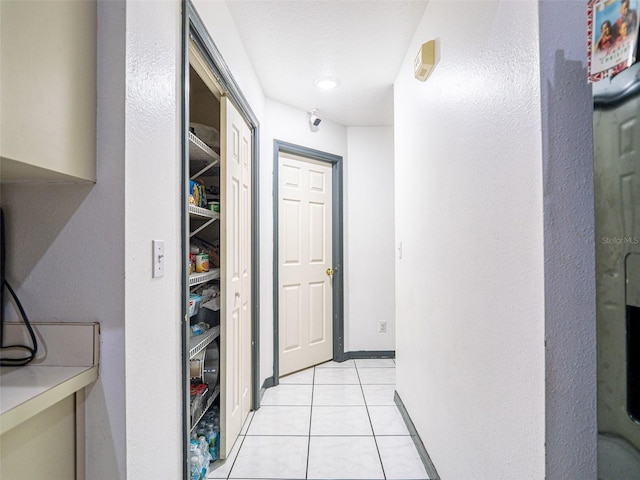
[227,0,427,126]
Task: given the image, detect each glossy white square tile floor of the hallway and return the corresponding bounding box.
[208,359,429,480]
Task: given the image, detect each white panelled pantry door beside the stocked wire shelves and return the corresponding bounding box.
[220,97,251,458]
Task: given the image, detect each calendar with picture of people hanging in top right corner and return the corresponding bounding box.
[587,0,640,83]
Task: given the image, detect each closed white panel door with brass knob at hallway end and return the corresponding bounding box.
[278,153,333,375]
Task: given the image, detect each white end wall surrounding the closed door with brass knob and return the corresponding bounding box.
[260,99,395,356]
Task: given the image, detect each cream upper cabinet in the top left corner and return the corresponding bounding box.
[0,0,97,182]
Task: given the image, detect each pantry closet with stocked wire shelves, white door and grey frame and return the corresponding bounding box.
[182,1,260,479]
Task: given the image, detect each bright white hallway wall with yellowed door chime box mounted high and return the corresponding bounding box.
[394,1,545,480]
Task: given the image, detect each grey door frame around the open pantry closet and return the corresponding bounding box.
[180,0,260,478]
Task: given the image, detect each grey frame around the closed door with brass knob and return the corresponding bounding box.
[273,140,346,385]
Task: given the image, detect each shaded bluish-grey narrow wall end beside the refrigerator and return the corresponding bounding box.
[540,0,597,478]
